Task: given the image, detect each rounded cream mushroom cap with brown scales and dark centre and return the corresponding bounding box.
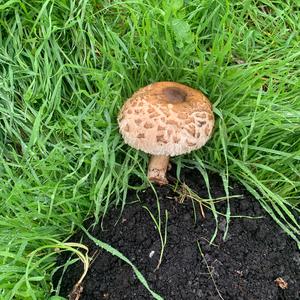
[118,82,214,156]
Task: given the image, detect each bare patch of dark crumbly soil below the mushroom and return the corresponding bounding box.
[53,170,300,300]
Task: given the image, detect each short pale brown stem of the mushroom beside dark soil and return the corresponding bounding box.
[148,155,169,185]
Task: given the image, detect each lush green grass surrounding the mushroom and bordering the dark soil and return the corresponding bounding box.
[0,0,300,299]
